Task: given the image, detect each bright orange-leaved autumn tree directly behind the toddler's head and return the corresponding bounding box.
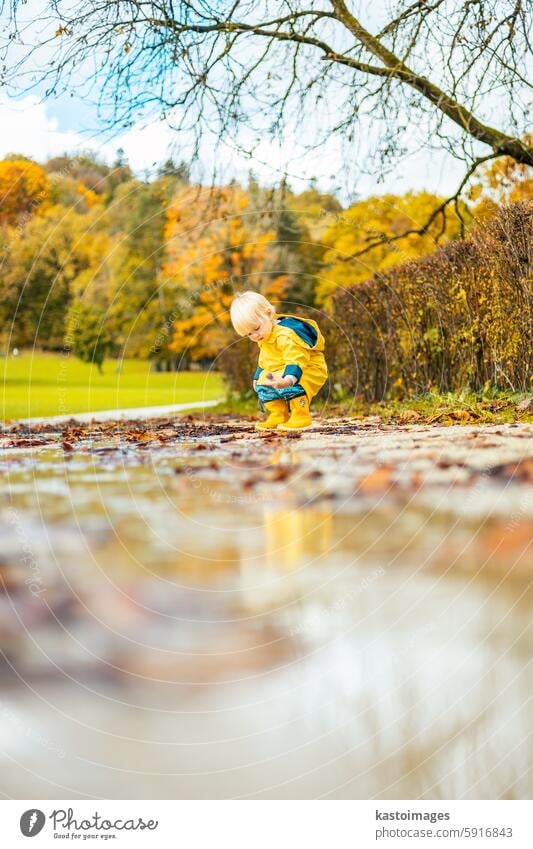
[163,184,286,360]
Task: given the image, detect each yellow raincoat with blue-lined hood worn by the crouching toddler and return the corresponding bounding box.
[254,314,328,401]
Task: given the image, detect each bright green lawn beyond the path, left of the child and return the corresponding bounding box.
[0,352,225,421]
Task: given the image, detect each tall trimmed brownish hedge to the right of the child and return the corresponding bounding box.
[327,202,533,400]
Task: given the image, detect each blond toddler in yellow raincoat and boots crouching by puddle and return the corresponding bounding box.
[230,292,328,431]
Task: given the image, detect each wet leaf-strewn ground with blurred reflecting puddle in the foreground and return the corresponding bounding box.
[0,417,533,799]
